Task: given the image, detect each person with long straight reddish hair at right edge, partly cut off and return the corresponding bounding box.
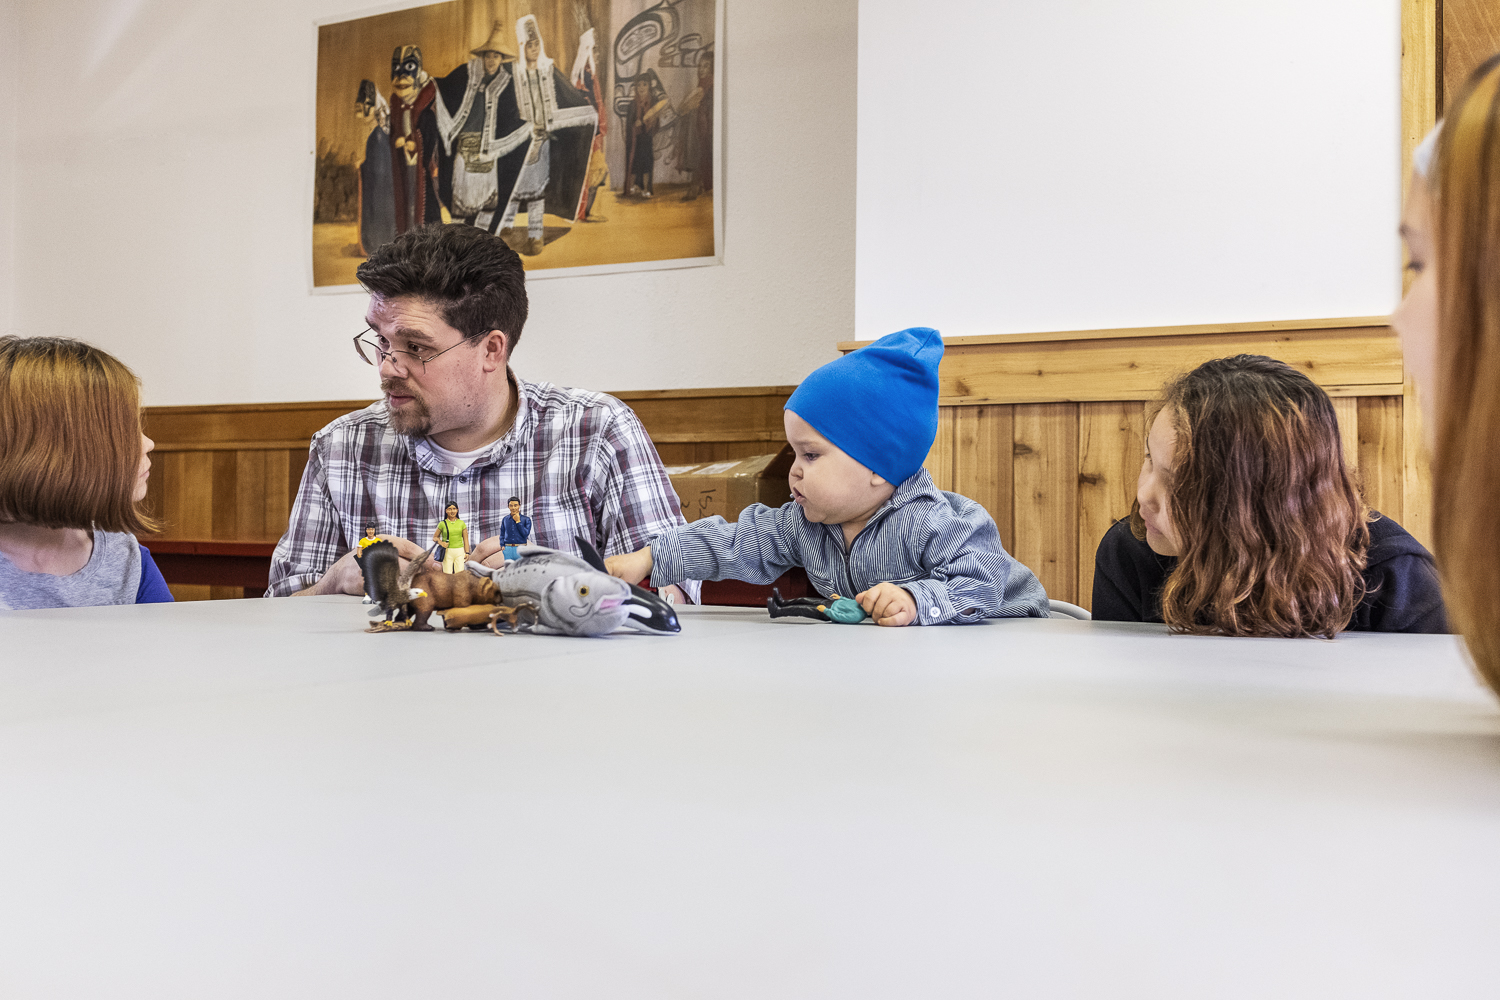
[1391,55,1500,691]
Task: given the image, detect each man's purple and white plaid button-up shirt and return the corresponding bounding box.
[266,376,699,601]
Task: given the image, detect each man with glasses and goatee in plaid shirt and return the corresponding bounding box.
[266,225,698,600]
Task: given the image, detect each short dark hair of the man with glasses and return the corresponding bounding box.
[354,222,527,355]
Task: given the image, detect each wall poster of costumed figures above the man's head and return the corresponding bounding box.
[311,0,725,284]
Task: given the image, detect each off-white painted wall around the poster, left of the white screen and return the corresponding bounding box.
[0,0,857,405]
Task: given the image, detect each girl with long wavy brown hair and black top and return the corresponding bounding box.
[1094,354,1448,639]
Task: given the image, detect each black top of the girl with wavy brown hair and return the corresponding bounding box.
[1092,511,1448,633]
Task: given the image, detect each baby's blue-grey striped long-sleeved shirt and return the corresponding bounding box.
[651,469,1047,625]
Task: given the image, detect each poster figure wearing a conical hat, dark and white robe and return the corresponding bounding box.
[432,21,531,232]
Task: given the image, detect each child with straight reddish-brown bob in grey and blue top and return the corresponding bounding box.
[0,337,173,610]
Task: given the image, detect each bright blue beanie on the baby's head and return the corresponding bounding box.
[786,327,942,486]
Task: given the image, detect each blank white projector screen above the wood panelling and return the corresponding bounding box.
[855,0,1401,339]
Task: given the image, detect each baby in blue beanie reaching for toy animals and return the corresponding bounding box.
[605,327,1047,625]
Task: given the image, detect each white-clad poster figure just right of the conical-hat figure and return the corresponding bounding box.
[500,13,599,256]
